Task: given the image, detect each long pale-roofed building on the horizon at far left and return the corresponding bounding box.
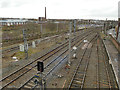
[0,19,28,26]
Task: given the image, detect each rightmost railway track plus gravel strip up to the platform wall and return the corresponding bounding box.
[97,38,118,90]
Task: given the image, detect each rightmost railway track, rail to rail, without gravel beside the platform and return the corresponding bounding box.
[97,36,111,88]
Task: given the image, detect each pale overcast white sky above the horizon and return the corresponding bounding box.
[0,0,119,20]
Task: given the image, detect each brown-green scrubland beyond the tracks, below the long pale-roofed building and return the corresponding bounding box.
[2,22,68,47]
